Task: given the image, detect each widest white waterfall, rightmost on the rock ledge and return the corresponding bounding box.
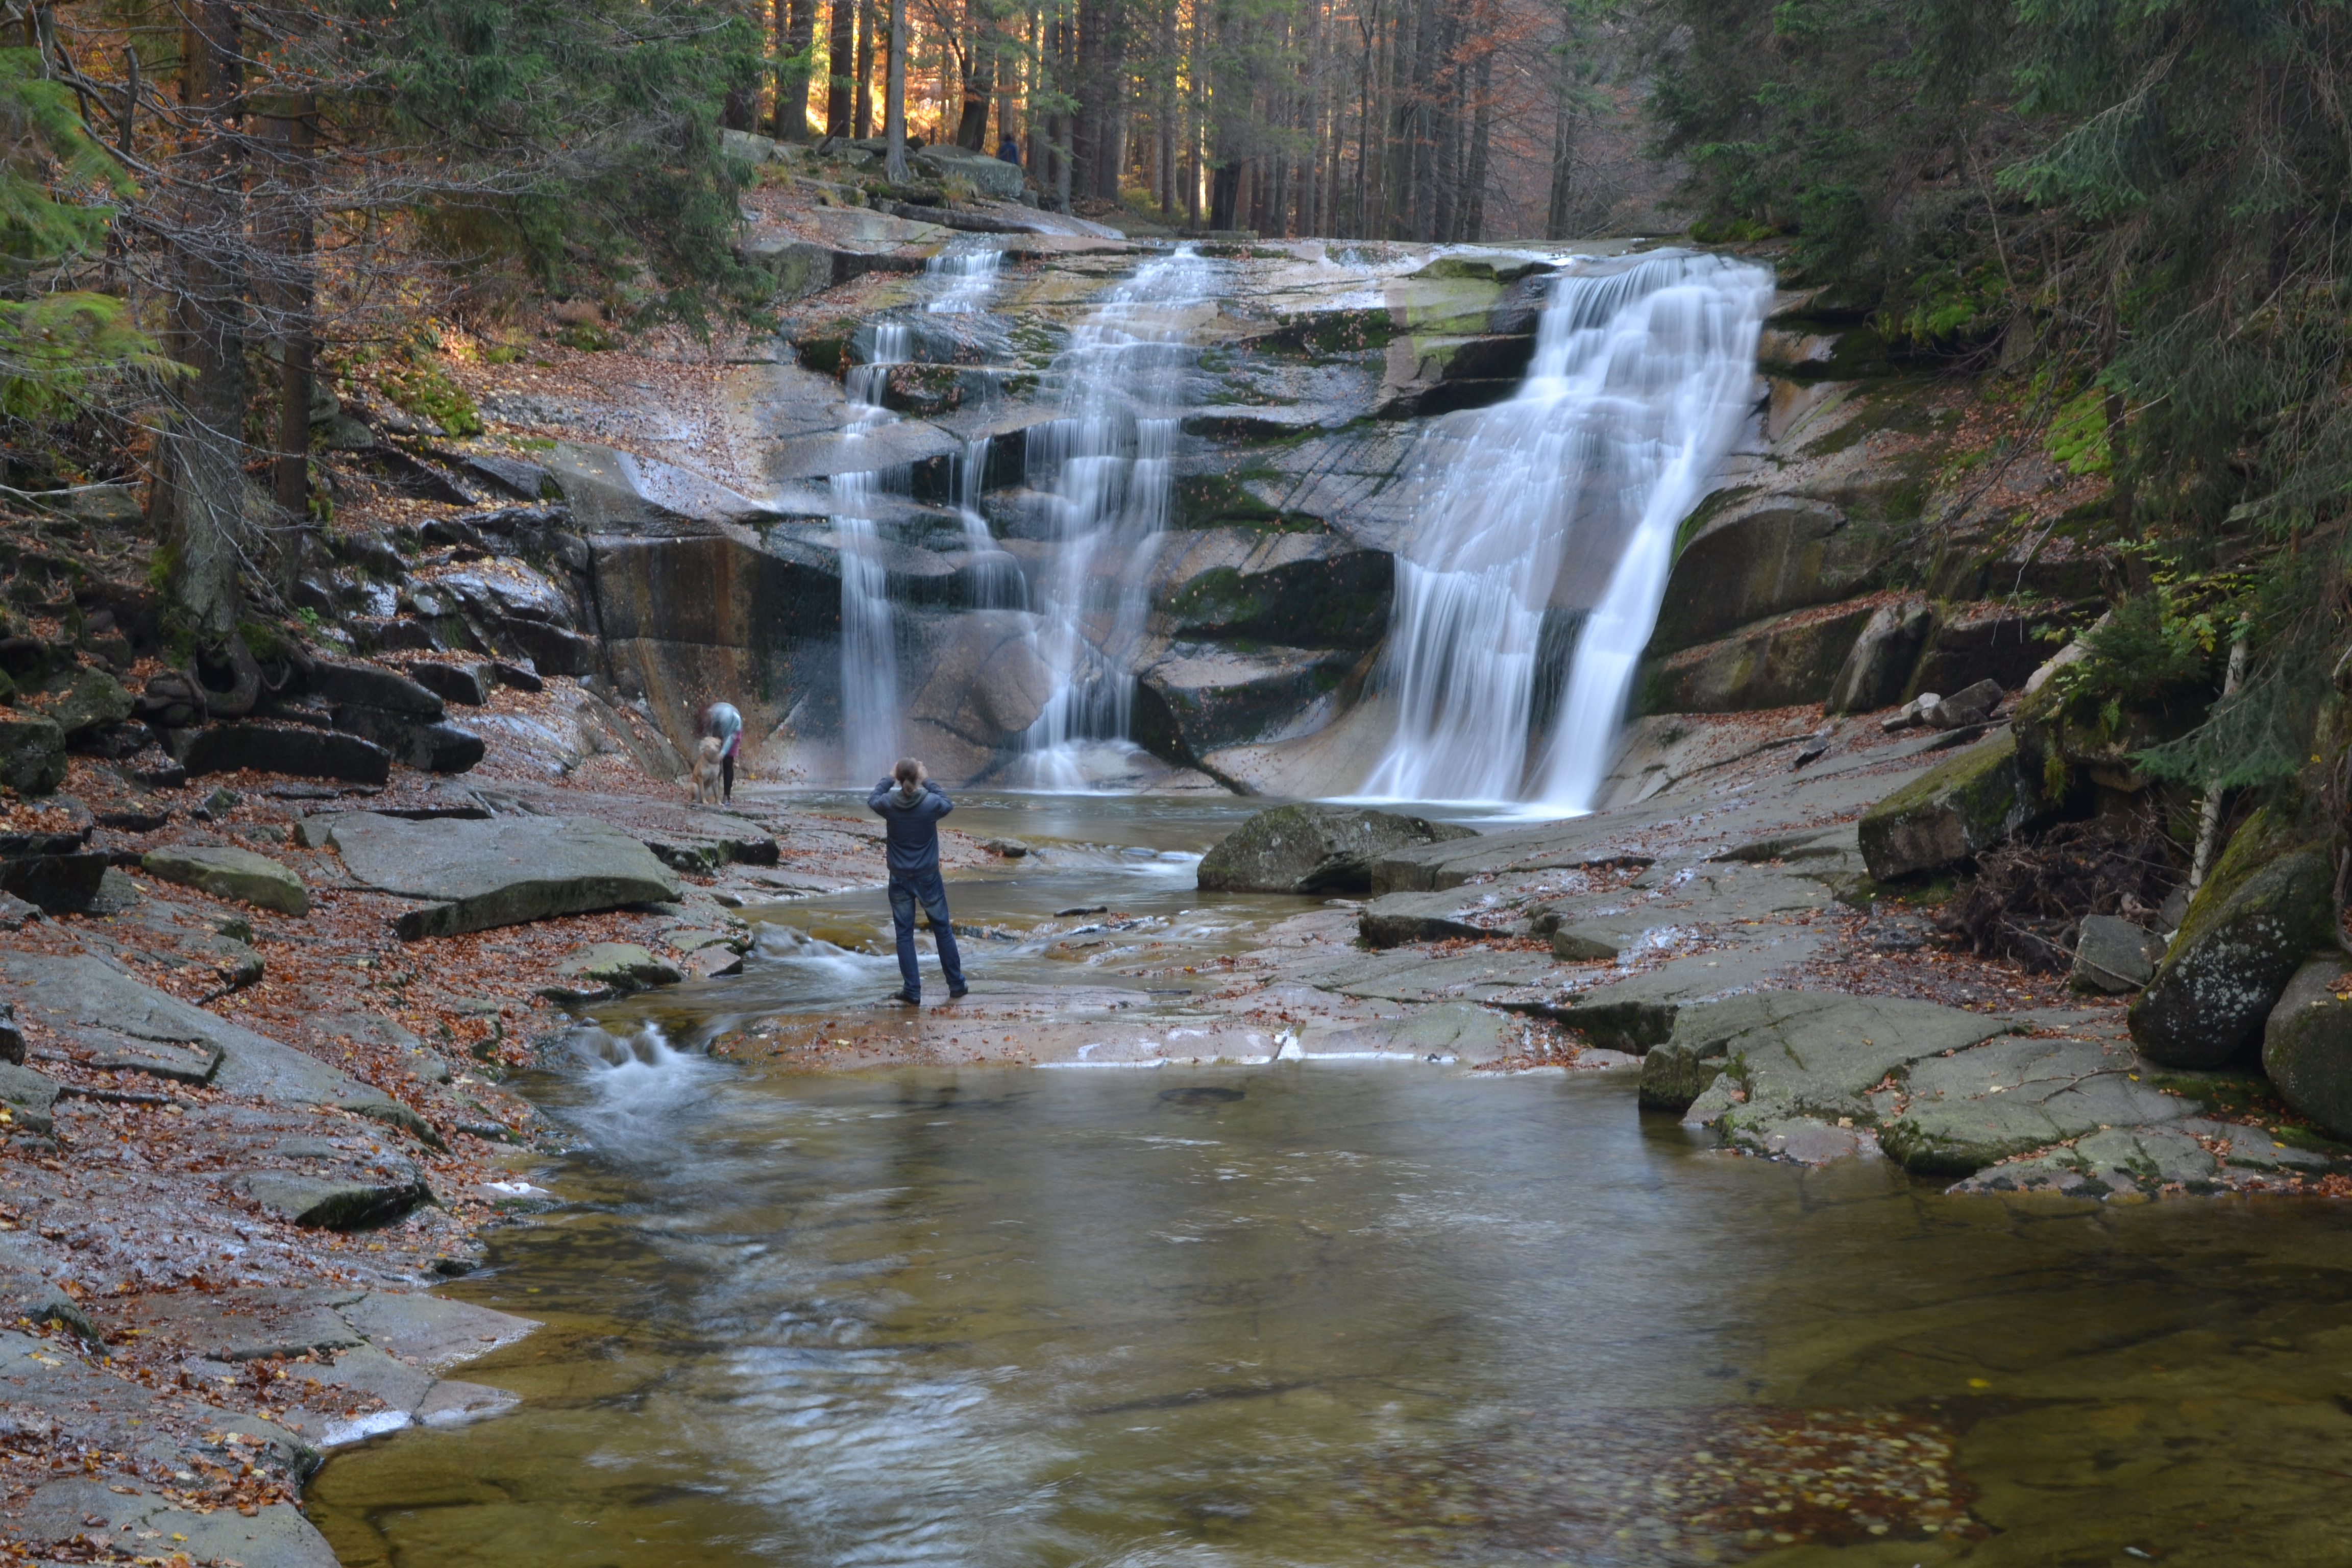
[1364,254,1771,811]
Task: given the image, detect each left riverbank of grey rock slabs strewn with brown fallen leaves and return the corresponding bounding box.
[0,709,988,1568]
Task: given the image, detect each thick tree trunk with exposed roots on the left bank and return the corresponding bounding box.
[155,0,259,647]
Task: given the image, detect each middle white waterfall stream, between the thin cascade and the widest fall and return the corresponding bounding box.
[1023,247,1216,790]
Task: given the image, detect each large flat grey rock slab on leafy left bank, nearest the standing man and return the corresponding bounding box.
[327,811,680,940]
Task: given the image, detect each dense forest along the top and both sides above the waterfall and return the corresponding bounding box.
[0,0,2352,783]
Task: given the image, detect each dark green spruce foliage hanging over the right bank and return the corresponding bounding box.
[1647,0,2352,783]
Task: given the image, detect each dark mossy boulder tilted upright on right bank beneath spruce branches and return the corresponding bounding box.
[2131,808,2333,1067]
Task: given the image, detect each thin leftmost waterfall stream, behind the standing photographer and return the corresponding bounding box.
[830,247,1004,783]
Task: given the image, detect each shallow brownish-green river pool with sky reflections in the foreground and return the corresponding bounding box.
[313,802,2352,1568]
